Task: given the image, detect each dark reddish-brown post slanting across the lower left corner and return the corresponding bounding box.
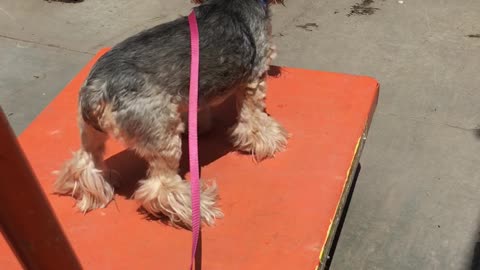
[0,108,82,270]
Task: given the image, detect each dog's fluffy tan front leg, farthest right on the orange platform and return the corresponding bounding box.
[230,78,288,161]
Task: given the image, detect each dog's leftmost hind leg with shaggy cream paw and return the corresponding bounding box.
[54,117,114,212]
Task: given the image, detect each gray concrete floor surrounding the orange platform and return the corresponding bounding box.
[0,0,480,270]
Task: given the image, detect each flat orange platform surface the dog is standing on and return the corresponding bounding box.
[0,49,378,270]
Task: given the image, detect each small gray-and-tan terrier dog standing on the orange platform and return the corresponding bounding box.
[54,0,288,228]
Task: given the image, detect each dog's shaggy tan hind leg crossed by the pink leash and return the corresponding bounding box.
[134,102,222,228]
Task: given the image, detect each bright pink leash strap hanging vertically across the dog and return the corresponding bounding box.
[188,11,201,270]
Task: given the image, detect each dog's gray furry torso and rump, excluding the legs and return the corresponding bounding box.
[80,0,271,137]
